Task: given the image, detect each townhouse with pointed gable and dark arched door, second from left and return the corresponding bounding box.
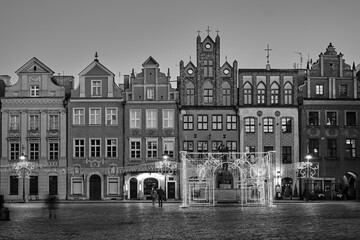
[67,55,124,200]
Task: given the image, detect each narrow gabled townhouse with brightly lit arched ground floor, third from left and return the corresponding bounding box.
[124,56,180,199]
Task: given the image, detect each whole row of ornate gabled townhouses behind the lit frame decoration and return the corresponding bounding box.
[0,32,360,201]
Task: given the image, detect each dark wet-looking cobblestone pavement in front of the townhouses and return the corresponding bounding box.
[0,201,360,239]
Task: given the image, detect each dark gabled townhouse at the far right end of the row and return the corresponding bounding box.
[299,43,360,199]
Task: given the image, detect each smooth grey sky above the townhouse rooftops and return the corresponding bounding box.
[0,0,360,86]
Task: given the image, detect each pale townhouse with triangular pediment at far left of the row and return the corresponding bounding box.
[0,57,73,201]
